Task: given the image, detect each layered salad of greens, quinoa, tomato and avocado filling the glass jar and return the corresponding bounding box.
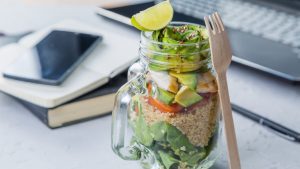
[129,0,218,169]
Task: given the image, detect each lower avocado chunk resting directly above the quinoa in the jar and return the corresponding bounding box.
[175,86,203,107]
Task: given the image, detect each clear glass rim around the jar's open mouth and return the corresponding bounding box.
[141,21,208,47]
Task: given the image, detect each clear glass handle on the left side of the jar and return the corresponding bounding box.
[111,74,144,160]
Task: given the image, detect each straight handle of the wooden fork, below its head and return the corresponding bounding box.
[217,72,241,169]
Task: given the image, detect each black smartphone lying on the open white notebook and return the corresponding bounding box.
[3,30,102,85]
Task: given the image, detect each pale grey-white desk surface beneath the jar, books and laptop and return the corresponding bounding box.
[0,0,300,169]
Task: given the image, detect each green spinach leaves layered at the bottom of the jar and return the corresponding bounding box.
[135,115,207,169]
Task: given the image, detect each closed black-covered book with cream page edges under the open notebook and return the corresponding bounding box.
[14,72,127,128]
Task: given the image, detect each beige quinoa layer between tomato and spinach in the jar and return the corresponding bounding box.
[141,94,217,147]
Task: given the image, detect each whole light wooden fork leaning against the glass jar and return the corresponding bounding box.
[204,12,241,169]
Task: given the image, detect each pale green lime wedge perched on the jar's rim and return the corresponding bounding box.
[131,1,173,31]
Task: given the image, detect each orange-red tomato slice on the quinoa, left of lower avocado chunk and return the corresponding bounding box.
[148,97,183,113]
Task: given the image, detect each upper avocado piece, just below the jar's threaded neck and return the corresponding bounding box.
[170,72,197,90]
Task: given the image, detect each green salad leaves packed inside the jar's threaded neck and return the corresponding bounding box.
[148,25,210,73]
